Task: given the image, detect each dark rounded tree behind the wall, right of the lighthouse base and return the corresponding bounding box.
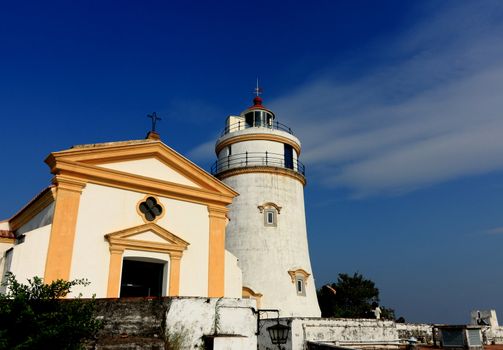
[318,273,394,319]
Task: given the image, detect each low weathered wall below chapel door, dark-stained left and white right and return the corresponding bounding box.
[87,297,257,350]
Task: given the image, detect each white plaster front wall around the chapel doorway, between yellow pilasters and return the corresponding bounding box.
[70,184,209,297]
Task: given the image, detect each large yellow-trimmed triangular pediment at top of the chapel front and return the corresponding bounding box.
[46,140,237,203]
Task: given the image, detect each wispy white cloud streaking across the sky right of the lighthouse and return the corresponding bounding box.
[269,2,503,196]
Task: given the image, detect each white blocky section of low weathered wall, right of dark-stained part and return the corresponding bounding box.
[165,298,257,350]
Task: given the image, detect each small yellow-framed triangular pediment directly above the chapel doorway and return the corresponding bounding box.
[105,223,189,252]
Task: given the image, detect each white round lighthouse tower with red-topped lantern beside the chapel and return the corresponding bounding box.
[212,87,320,317]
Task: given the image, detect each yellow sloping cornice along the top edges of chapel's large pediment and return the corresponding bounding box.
[45,140,237,197]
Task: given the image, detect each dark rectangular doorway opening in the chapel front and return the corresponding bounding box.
[120,260,164,297]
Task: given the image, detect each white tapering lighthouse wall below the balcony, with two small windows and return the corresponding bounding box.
[223,173,320,317]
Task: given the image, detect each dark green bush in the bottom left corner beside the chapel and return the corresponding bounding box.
[0,273,101,350]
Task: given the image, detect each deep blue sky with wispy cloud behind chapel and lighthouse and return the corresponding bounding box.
[0,0,503,323]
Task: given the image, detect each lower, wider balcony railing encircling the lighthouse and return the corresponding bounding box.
[211,152,306,176]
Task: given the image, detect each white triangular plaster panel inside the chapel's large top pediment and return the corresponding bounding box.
[99,158,199,187]
